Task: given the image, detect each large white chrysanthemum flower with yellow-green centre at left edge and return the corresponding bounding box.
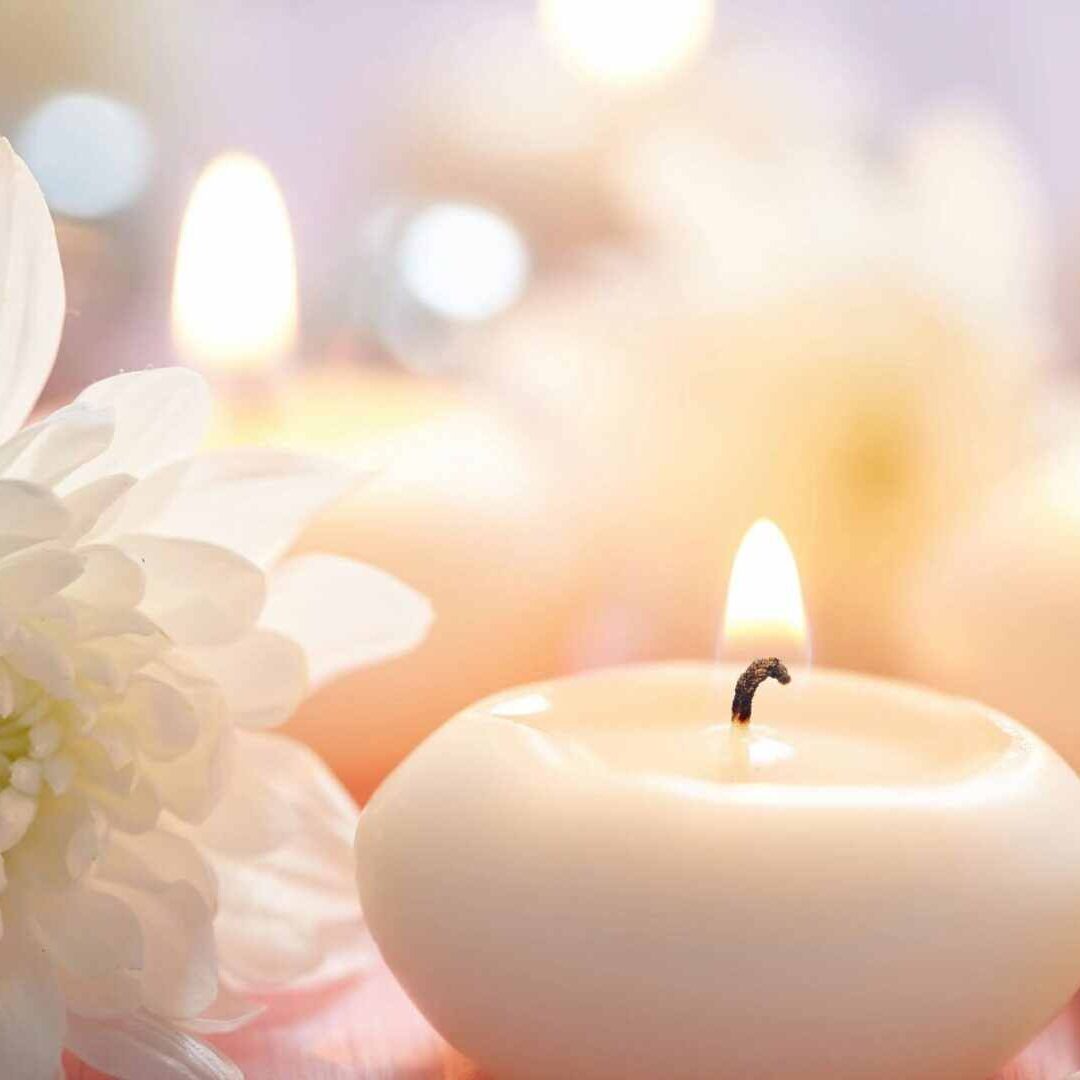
[0,140,430,1080]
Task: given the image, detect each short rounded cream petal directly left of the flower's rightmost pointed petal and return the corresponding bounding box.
[116,536,266,645]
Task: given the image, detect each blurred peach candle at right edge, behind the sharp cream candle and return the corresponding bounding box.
[906,443,1080,769]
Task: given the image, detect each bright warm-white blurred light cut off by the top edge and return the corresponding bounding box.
[540,0,714,84]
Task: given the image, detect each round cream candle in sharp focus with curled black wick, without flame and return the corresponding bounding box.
[356,518,1080,1080]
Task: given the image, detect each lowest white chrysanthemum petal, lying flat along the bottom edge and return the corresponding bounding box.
[67,1016,243,1080]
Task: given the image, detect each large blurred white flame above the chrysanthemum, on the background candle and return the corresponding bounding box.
[173,151,297,375]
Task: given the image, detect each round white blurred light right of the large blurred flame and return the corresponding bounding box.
[397,203,530,322]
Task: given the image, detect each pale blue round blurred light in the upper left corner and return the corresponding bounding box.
[15,93,153,218]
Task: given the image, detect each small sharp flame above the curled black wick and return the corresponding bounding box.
[721,517,810,663]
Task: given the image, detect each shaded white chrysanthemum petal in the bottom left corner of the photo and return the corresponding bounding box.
[0,920,64,1080]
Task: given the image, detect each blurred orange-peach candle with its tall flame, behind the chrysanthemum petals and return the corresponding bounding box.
[173,153,596,798]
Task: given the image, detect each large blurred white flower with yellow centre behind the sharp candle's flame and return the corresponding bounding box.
[471,50,1056,671]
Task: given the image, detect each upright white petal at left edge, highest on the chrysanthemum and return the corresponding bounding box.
[0,139,65,440]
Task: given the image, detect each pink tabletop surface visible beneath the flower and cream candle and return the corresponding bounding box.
[67,963,1080,1080]
